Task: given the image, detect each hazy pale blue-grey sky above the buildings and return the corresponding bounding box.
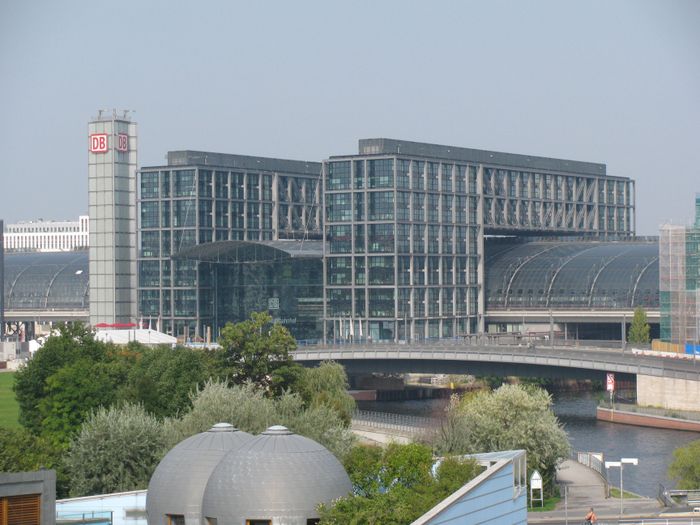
[0,0,700,235]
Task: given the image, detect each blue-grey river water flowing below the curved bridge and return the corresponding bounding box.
[360,392,700,497]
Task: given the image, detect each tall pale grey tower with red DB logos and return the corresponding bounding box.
[88,110,137,326]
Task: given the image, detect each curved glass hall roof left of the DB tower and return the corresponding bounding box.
[5,250,90,311]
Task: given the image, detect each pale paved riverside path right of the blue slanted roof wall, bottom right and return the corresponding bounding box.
[528,460,661,523]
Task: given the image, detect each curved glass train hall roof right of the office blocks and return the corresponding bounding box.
[486,241,659,310]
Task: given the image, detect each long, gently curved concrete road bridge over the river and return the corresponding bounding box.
[294,341,700,411]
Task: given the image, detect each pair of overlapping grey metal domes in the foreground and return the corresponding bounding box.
[146,423,352,525]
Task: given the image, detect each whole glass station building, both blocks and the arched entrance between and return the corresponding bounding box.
[138,139,634,341]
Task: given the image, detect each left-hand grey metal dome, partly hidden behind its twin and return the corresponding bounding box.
[146,423,253,525]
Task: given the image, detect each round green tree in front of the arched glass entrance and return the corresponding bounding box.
[218,312,296,393]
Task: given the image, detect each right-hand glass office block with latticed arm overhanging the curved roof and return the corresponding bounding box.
[323,139,634,341]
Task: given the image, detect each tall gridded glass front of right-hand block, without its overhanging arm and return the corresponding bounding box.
[324,157,480,340]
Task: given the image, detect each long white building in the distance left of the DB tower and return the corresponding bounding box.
[4,215,90,252]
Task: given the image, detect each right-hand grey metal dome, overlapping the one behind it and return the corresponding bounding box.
[202,426,352,525]
